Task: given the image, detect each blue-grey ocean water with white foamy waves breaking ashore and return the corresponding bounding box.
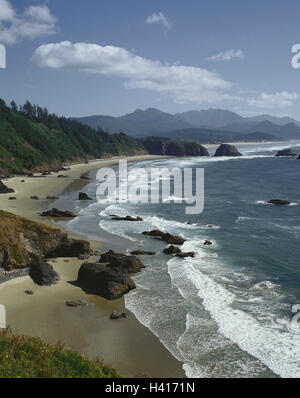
[62,142,300,377]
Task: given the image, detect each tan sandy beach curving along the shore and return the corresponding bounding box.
[0,155,186,378]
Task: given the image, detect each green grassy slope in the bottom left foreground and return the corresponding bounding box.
[0,328,120,378]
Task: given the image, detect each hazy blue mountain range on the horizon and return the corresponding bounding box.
[73,108,300,142]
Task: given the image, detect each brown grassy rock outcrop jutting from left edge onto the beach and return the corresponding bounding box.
[0,211,90,271]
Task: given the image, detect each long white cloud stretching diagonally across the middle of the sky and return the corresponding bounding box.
[32,41,232,104]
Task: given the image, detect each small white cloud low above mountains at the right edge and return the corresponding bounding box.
[248,91,299,109]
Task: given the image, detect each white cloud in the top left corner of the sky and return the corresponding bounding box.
[0,0,56,44]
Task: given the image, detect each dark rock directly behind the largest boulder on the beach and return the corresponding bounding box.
[99,250,145,274]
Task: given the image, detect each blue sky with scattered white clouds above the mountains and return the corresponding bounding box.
[0,0,300,120]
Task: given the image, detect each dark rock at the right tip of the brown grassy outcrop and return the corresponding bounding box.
[47,238,91,260]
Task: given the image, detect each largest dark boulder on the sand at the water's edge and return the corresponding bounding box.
[77,263,136,300]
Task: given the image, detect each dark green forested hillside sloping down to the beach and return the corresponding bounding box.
[0,99,143,172]
